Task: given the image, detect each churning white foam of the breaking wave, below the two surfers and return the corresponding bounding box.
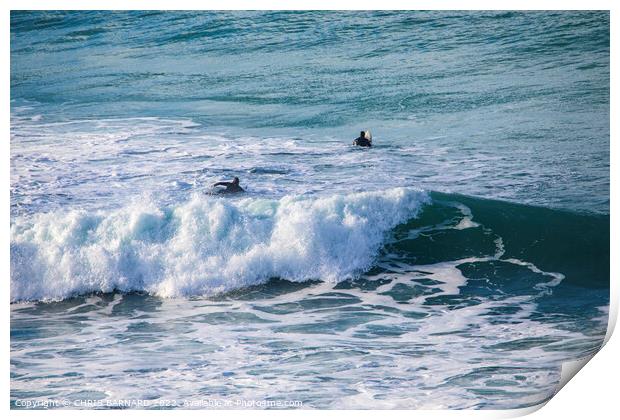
[11,188,430,302]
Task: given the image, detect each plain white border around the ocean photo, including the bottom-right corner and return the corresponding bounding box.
[0,0,620,420]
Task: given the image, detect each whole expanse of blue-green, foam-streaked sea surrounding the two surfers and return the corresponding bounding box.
[10,11,610,409]
